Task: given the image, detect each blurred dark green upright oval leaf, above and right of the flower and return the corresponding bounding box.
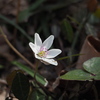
[62,19,74,43]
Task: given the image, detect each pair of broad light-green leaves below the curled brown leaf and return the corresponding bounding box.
[60,57,100,81]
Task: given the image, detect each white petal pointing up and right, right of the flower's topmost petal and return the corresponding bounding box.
[42,35,54,49]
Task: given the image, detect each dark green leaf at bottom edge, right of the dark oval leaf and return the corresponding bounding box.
[29,90,46,100]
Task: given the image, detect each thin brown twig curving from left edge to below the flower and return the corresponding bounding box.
[0,27,35,69]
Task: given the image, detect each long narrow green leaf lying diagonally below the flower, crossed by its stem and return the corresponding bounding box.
[12,61,47,86]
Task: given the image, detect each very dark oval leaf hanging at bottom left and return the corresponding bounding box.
[11,72,30,100]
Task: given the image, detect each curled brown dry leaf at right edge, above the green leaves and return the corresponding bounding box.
[76,36,100,68]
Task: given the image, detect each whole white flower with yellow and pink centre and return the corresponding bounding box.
[29,33,61,66]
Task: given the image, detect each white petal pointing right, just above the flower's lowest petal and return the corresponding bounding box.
[46,49,62,58]
